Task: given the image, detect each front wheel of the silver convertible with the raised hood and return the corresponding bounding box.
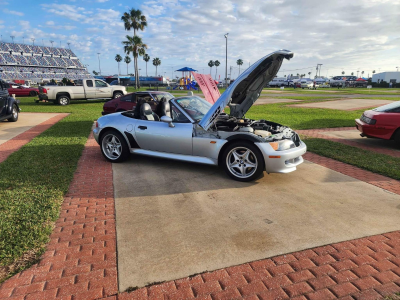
[222,141,264,182]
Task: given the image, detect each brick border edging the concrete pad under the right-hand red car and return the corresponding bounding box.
[296,127,400,157]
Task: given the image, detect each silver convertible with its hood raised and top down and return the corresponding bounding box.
[93,50,307,181]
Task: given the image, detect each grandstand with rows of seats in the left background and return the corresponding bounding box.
[0,42,92,83]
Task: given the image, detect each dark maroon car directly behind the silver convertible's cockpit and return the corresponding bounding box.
[102,91,174,116]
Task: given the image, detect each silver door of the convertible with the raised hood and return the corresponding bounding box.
[135,115,193,155]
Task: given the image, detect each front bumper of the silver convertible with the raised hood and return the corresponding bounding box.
[255,141,307,173]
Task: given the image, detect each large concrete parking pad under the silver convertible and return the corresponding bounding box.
[113,156,400,291]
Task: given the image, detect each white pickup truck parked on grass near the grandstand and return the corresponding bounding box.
[39,79,127,105]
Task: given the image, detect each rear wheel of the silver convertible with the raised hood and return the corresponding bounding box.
[100,130,130,163]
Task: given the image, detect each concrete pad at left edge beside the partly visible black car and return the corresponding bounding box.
[0,112,59,145]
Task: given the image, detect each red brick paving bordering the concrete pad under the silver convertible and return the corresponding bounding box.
[0,132,400,300]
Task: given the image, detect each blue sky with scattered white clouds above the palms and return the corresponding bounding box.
[0,0,400,79]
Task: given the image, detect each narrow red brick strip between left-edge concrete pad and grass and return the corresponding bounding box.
[0,113,69,163]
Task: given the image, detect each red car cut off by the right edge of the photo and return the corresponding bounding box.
[356,101,400,147]
